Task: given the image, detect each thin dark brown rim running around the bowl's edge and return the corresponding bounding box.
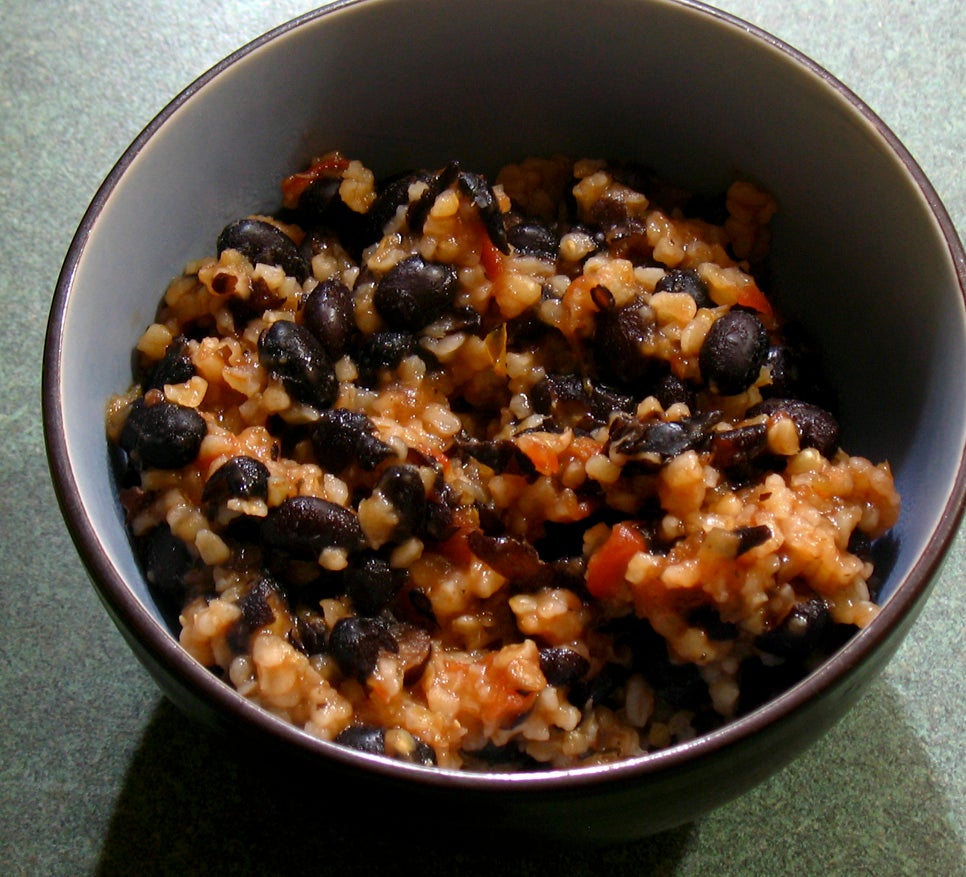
[41,0,966,792]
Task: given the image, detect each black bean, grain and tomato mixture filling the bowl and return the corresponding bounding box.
[107,152,900,770]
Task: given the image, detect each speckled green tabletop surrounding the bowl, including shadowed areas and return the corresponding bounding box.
[0,0,966,875]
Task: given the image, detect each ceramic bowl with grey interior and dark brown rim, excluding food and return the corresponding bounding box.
[43,0,966,840]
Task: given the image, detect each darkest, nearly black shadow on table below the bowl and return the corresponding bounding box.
[97,700,690,877]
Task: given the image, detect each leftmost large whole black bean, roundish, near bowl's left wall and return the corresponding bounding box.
[121,398,208,469]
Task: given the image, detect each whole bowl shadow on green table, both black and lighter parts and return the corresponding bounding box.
[92,685,966,877]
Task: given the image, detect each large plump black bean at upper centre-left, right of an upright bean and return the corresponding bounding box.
[373,255,459,332]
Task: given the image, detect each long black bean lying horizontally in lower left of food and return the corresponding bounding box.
[261,496,365,559]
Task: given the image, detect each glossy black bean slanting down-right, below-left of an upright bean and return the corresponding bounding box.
[258,320,339,408]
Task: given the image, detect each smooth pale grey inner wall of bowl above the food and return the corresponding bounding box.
[45,0,966,752]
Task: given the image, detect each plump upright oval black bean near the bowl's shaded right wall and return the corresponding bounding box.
[698,310,768,396]
